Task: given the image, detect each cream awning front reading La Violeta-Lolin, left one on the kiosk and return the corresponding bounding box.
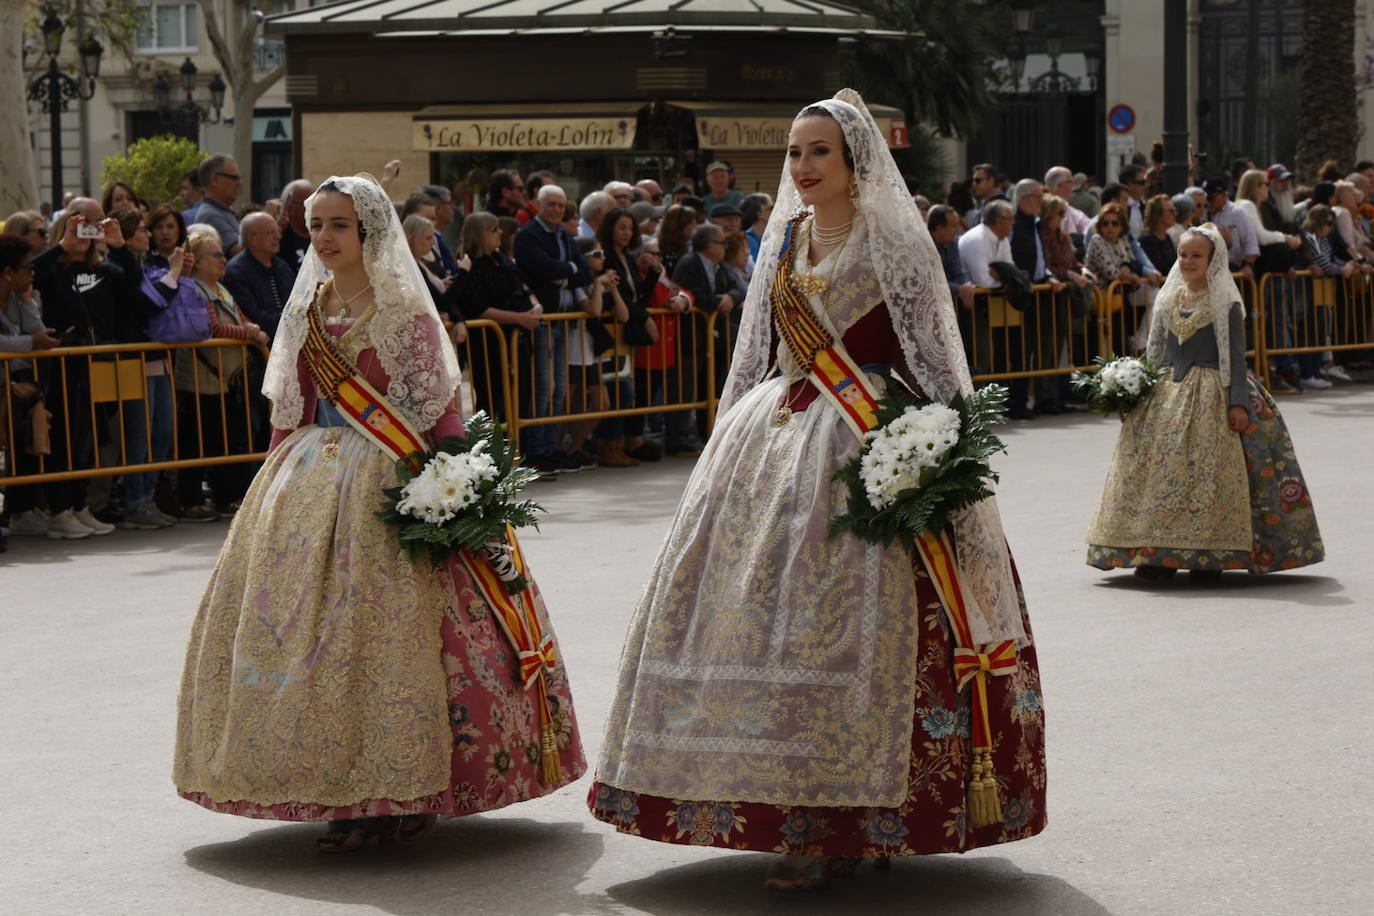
[411,102,644,152]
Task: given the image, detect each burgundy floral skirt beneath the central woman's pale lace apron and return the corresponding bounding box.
[587,565,1046,857]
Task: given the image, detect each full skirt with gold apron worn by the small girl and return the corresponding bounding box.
[1087,369,1326,573]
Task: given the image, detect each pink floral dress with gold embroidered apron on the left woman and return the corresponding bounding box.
[173,319,587,821]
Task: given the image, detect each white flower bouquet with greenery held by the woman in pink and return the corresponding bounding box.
[381,411,544,595]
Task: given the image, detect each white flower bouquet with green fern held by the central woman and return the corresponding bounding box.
[830,385,1007,549]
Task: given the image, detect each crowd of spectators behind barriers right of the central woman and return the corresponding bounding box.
[934,153,1374,420]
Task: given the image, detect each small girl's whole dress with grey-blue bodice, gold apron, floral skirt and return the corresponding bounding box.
[1087,306,1325,573]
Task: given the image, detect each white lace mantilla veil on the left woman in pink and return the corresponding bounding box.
[262,174,459,431]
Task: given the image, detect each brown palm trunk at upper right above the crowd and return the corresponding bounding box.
[1294,0,1359,183]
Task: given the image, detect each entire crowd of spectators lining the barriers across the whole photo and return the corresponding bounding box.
[0,144,1374,552]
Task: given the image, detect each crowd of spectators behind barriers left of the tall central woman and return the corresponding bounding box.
[0,154,772,544]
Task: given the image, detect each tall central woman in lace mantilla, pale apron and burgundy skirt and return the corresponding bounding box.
[588,89,1046,890]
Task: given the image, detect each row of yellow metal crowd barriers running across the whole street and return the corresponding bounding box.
[8,271,1374,486]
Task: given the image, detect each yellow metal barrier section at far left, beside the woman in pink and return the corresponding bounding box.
[0,339,269,486]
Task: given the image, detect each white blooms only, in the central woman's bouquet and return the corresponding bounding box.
[859,404,960,509]
